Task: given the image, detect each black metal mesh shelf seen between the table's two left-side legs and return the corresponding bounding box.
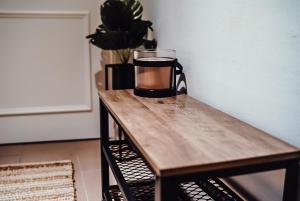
[105,140,155,201]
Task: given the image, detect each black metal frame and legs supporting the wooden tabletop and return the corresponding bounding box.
[100,99,299,201]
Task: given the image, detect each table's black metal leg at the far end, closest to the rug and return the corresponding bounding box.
[100,99,109,200]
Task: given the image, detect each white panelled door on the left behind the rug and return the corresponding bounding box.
[0,0,101,144]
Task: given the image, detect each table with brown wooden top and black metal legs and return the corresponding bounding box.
[99,90,300,201]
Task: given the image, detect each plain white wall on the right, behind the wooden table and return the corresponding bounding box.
[143,0,300,201]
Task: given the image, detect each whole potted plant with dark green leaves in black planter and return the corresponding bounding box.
[87,0,156,89]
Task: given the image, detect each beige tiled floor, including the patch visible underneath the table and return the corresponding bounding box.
[0,140,292,201]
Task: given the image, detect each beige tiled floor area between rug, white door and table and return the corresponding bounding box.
[0,140,101,201]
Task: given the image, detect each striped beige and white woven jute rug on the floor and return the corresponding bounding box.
[0,161,76,201]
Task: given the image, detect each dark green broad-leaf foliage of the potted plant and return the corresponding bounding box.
[87,0,156,61]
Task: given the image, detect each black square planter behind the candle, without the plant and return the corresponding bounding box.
[105,64,135,90]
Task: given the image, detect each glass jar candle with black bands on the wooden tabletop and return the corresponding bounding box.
[133,50,177,97]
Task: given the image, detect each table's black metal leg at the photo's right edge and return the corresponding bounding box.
[283,160,299,201]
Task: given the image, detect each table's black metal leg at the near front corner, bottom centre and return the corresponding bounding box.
[155,177,178,201]
